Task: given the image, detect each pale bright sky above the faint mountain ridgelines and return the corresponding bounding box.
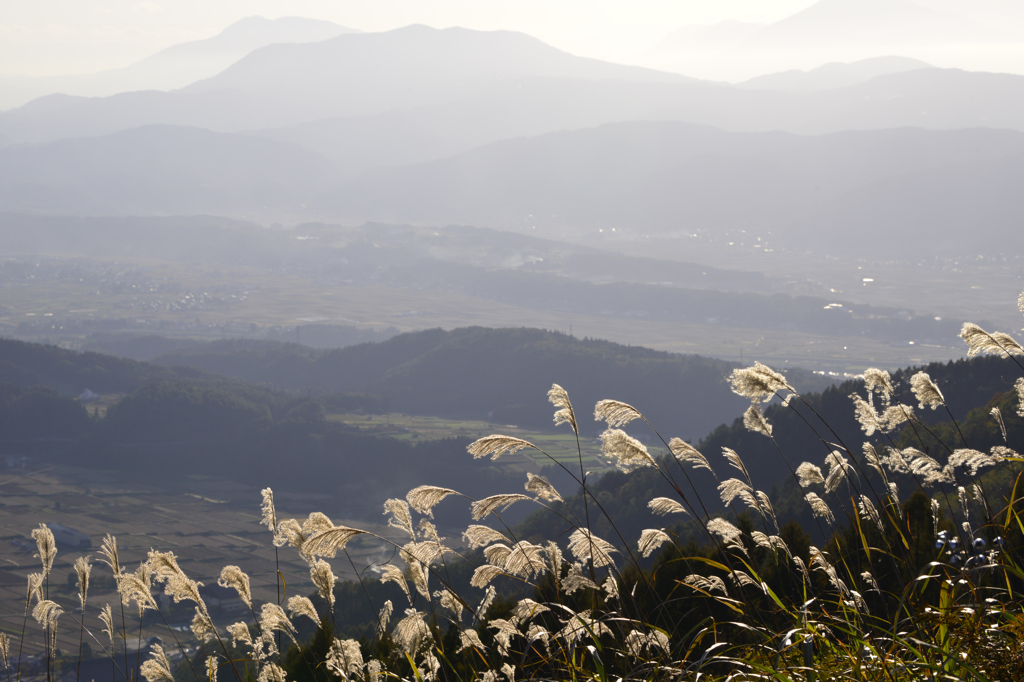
[6,0,1024,76]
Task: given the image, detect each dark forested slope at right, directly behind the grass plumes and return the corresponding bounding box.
[521,356,1024,542]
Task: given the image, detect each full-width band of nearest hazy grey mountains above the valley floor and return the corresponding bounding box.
[8,122,1024,259]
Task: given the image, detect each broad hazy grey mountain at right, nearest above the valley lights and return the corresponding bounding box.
[316,123,1024,250]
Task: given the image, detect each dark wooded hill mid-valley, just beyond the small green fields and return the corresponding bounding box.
[154,327,821,438]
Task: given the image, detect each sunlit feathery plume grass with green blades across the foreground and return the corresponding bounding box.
[6,294,1024,682]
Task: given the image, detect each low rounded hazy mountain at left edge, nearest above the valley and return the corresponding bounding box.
[0,126,334,214]
